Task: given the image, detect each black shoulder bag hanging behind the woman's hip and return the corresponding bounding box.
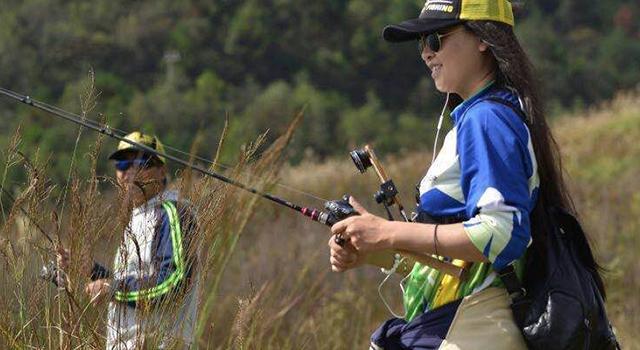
[499,208,620,350]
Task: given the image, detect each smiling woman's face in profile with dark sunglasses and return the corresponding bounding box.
[421,25,494,99]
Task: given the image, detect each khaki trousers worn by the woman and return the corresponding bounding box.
[439,288,527,350]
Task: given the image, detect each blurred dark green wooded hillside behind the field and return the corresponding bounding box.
[0,0,640,185]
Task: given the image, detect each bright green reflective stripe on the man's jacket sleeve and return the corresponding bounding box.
[115,202,185,301]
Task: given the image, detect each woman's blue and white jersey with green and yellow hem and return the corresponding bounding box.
[404,84,539,319]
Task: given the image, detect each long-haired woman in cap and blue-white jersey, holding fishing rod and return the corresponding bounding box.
[329,0,588,349]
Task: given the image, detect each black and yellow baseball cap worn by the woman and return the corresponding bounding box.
[382,0,514,42]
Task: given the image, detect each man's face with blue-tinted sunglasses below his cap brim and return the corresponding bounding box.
[115,152,166,202]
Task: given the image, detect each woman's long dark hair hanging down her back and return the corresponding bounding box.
[465,21,605,297]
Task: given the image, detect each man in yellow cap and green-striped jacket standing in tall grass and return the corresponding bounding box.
[59,132,198,350]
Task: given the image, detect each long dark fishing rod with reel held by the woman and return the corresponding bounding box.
[0,87,356,226]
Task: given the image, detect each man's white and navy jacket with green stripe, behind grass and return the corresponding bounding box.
[107,191,198,350]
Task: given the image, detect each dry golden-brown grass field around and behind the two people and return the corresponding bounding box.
[0,89,640,349]
